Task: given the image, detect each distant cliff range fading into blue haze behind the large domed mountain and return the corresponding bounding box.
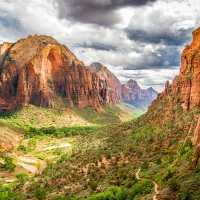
[88,63,158,110]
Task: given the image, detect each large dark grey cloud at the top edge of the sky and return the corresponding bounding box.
[54,0,157,26]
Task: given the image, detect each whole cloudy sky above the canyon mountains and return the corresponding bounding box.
[0,0,200,91]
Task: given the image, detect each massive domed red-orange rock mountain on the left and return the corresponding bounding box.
[0,35,110,111]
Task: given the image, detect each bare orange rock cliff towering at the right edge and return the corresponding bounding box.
[153,28,200,111]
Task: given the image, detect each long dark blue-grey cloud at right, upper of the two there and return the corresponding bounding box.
[125,28,193,45]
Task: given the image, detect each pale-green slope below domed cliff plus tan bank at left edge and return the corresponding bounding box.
[0,102,136,151]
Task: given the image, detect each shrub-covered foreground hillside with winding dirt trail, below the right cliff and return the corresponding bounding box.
[7,97,200,199]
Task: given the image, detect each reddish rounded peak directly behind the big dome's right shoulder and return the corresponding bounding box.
[88,62,122,102]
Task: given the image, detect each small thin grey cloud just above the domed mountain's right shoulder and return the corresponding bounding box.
[77,42,117,51]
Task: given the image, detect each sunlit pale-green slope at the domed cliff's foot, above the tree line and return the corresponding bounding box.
[0,104,134,129]
